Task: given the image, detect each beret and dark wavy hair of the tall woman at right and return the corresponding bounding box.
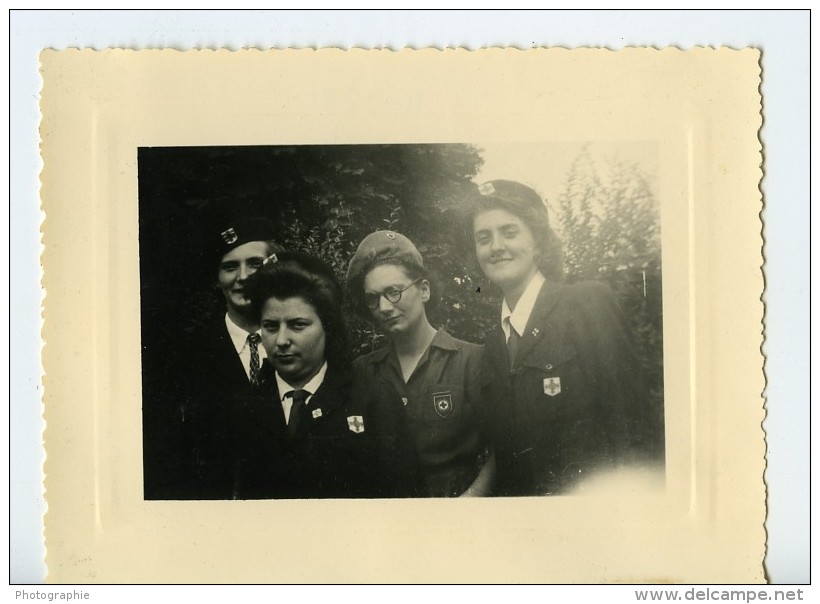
[465,180,564,281]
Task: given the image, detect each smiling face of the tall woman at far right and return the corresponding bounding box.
[473,208,539,293]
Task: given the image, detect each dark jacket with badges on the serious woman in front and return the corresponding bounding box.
[226,365,373,499]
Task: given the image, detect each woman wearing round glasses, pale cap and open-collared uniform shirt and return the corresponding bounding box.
[347,231,493,497]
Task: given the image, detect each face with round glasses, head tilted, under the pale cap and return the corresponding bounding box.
[364,264,430,337]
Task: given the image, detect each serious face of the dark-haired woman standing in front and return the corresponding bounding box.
[261,296,326,388]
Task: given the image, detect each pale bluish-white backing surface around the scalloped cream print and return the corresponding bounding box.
[9,11,810,584]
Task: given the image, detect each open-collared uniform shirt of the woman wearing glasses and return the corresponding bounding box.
[354,330,487,497]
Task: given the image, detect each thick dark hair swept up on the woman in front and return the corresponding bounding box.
[240,252,350,369]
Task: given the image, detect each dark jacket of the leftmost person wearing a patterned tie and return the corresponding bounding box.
[144,314,252,499]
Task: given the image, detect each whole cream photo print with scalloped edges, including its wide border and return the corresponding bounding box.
[41,48,766,584]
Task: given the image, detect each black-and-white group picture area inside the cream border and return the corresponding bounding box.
[138,141,665,500]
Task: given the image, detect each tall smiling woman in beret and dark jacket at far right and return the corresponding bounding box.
[468,180,658,495]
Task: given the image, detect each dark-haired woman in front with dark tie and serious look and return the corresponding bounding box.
[225,253,370,499]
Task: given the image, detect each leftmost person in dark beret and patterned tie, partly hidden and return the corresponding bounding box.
[143,216,281,499]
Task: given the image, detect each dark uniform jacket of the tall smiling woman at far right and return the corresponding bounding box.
[484,281,659,495]
